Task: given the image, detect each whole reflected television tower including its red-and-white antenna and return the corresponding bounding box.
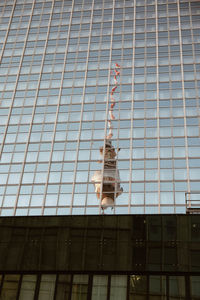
[91,64,123,210]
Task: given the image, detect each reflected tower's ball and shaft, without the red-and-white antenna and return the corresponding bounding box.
[92,140,123,210]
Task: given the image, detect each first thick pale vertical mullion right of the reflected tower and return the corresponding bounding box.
[128,0,136,214]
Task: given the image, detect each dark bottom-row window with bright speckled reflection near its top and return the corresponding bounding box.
[129,275,147,300]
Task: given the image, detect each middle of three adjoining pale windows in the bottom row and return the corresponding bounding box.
[92,275,108,300]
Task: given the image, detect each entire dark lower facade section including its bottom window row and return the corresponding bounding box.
[0,215,200,300]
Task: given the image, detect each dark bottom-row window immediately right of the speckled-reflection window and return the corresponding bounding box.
[149,276,167,300]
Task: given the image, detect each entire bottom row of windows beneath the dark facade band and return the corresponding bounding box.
[0,274,200,300]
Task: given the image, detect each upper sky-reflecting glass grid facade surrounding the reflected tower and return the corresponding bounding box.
[0,0,200,216]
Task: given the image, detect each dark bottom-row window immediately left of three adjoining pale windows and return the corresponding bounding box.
[56,275,71,300]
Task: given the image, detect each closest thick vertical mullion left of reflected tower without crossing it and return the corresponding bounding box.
[70,0,94,214]
